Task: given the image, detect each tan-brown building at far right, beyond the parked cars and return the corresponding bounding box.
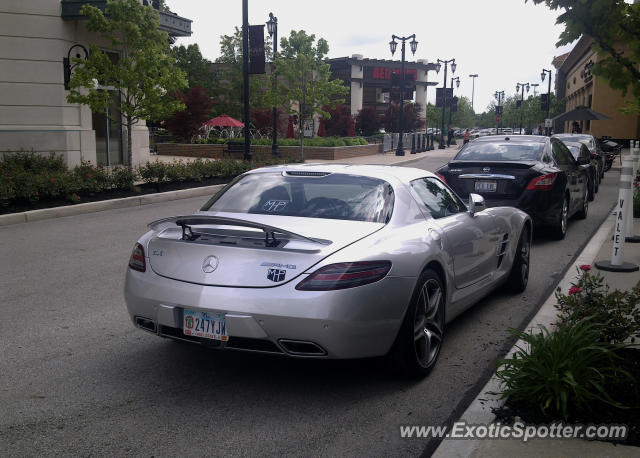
[553,36,640,140]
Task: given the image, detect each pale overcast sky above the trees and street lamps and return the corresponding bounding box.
[166,0,571,112]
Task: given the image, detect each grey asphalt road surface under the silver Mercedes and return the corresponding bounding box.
[0,152,618,457]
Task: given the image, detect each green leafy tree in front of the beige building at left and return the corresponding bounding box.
[67,0,187,164]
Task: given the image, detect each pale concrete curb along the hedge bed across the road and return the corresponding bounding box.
[0,184,225,226]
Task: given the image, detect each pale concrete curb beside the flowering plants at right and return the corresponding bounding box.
[431,209,616,458]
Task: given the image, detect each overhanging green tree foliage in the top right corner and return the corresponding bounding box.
[532,0,640,114]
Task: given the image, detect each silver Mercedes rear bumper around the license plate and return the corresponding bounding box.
[124,269,416,359]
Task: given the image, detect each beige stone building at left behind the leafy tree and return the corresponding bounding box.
[0,0,191,166]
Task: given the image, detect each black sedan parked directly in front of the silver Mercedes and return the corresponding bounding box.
[437,135,589,239]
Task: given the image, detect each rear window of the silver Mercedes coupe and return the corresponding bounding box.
[201,172,394,223]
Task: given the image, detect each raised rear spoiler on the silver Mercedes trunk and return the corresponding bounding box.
[148,215,331,246]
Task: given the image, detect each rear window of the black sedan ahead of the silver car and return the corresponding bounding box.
[454,141,544,161]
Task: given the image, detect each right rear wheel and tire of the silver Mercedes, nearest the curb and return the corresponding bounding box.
[389,269,446,379]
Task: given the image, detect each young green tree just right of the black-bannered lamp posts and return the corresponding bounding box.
[271,30,349,159]
